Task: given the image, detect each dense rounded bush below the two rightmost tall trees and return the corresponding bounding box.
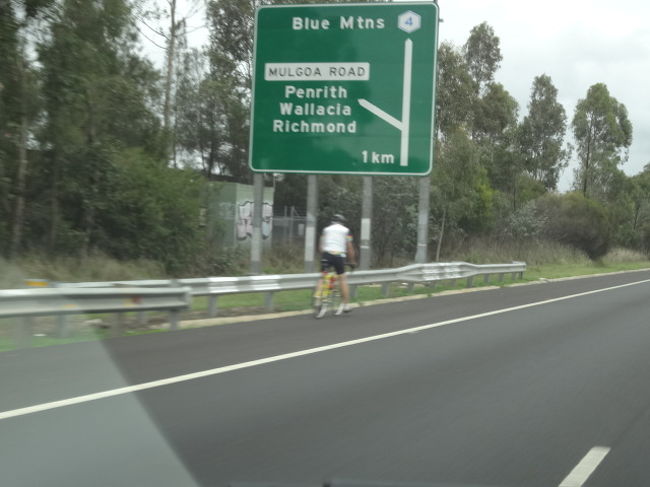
[537,192,611,259]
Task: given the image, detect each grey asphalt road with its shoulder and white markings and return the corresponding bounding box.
[0,271,650,487]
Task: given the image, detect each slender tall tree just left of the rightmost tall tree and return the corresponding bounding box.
[518,75,568,190]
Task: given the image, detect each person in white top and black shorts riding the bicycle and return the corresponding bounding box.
[315,213,355,315]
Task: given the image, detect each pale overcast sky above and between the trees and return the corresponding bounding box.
[167,0,650,191]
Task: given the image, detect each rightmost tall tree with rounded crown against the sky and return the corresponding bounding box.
[571,83,632,198]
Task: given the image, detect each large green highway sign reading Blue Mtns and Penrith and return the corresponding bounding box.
[249,2,438,176]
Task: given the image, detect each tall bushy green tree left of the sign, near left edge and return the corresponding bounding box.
[39,0,165,255]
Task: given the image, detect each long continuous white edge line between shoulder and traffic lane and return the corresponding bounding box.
[0,279,650,420]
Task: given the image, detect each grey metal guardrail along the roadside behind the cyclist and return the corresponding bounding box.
[0,262,526,346]
